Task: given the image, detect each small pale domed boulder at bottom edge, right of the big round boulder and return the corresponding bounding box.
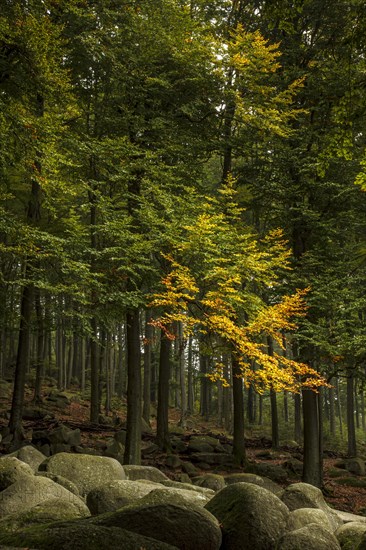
[275,523,341,550]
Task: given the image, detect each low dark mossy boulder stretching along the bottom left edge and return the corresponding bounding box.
[0,521,178,550]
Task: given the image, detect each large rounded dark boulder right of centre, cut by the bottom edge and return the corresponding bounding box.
[206,483,289,550]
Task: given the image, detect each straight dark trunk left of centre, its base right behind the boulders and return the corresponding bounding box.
[124,309,142,464]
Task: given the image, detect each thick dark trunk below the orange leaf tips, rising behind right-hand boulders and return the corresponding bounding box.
[302,389,323,487]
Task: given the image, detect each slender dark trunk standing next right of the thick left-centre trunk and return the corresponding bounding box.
[156,332,171,451]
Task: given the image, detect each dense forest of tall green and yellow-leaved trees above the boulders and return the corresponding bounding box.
[0,0,366,496]
